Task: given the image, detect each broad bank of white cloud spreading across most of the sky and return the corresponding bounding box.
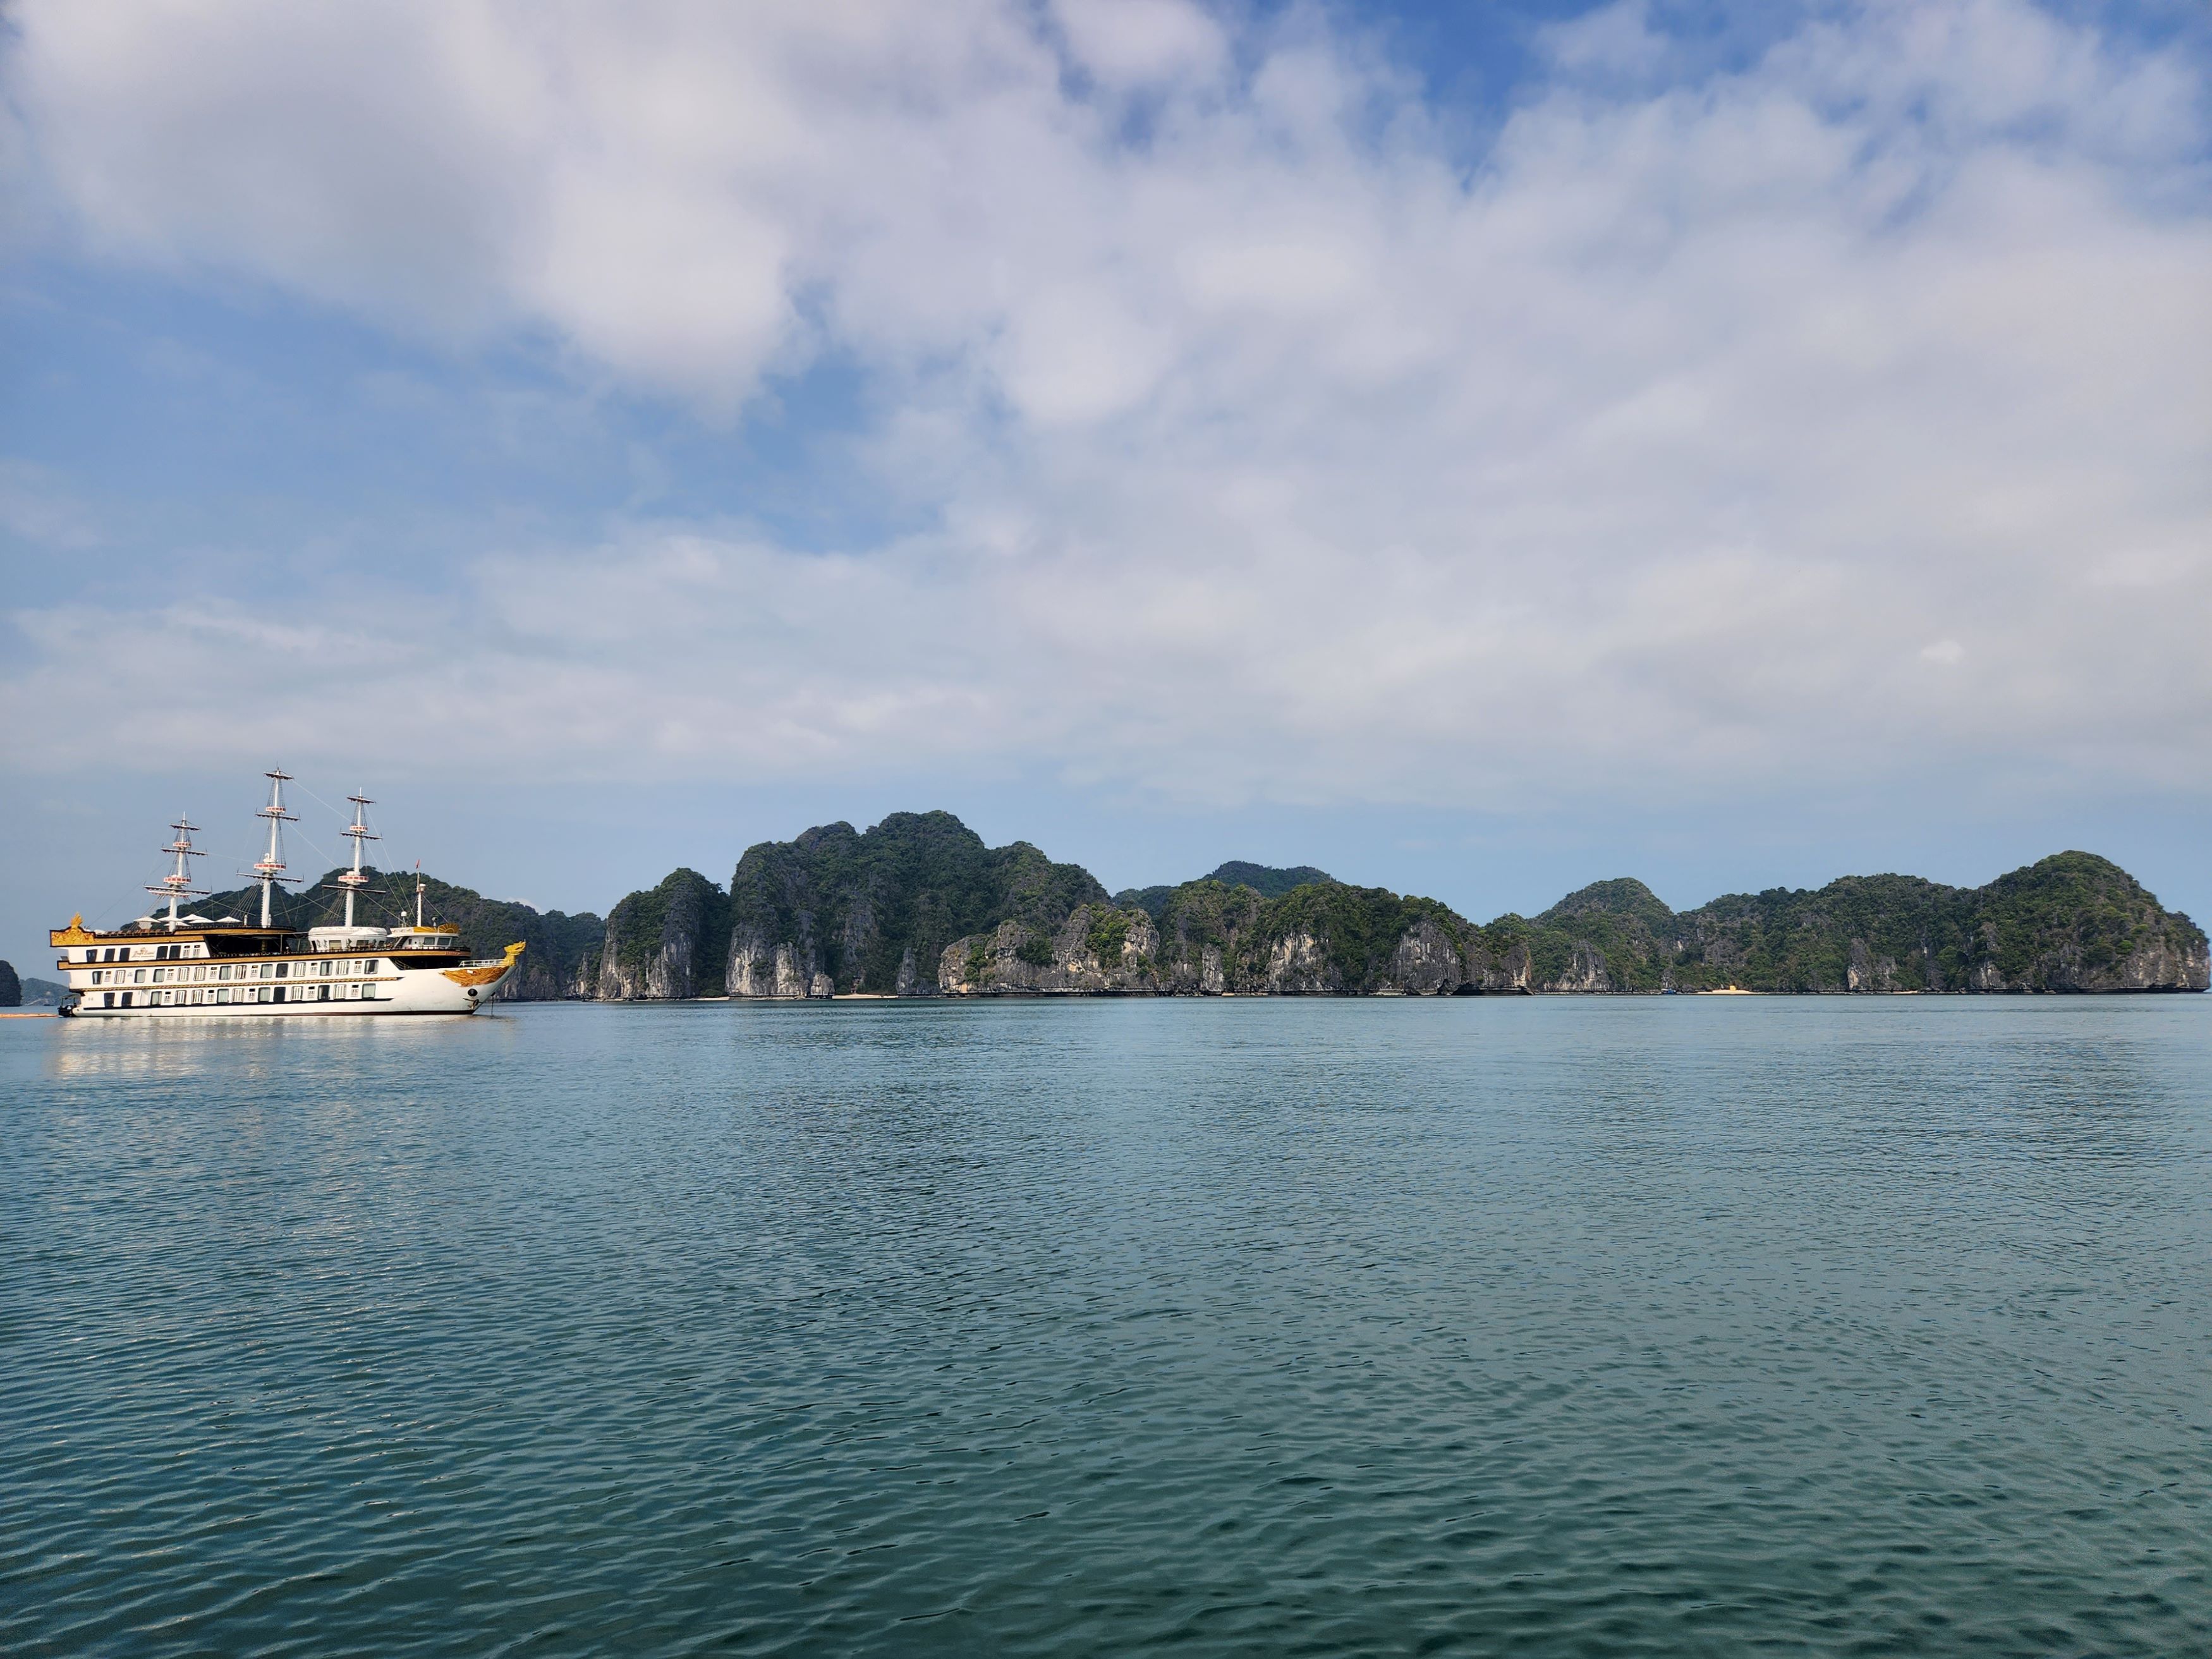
[0,0,2212,818]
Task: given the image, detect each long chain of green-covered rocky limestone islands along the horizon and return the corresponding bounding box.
[195,812,2212,1002]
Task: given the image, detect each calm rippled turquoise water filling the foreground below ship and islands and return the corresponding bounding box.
[0,998,2212,1657]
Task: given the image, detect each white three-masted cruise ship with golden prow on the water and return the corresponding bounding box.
[47,770,522,1020]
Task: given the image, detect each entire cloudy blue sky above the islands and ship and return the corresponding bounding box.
[0,0,2212,971]
